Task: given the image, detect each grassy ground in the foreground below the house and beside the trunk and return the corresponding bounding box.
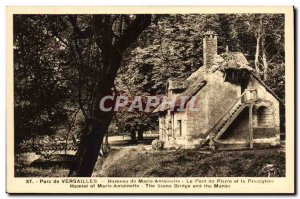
[16,145,285,177]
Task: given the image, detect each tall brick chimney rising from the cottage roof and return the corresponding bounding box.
[203,31,217,69]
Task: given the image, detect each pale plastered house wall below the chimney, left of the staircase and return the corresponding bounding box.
[187,71,241,143]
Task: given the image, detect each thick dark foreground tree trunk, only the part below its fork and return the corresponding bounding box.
[69,41,122,177]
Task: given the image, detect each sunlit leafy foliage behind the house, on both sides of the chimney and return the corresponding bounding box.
[117,14,284,96]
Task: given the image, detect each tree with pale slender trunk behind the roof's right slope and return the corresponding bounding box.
[235,14,284,80]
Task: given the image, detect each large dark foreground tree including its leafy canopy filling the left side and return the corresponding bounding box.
[14,15,151,176]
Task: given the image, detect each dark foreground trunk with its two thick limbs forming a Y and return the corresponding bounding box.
[69,15,151,177]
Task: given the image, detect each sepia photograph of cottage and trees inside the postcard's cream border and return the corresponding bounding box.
[7,6,294,192]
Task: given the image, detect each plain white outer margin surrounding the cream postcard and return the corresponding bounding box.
[0,0,300,199]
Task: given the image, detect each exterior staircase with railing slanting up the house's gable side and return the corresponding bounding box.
[200,89,256,146]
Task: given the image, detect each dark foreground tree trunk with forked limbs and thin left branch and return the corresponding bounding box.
[64,15,151,177]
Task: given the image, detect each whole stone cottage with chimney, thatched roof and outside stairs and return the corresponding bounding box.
[154,31,281,148]
